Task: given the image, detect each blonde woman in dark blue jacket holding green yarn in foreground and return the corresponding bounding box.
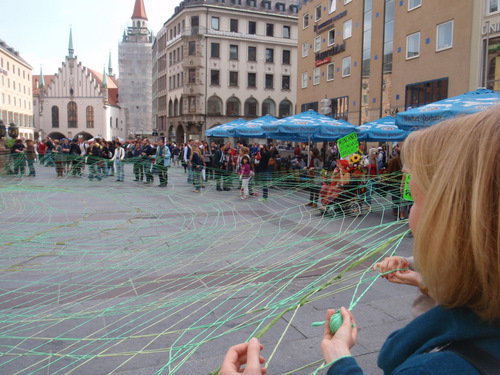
[220,106,500,375]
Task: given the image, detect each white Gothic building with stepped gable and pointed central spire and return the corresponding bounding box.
[32,33,126,140]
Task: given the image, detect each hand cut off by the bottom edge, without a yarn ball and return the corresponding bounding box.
[219,337,267,375]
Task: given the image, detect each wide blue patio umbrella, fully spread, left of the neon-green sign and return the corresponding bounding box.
[262,110,356,142]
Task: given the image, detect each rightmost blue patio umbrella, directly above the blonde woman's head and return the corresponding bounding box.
[396,89,500,131]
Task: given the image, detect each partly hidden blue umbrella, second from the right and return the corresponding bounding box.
[356,116,409,142]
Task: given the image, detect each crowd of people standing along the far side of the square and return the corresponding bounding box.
[1,137,407,214]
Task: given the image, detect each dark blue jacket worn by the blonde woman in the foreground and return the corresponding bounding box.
[328,306,500,375]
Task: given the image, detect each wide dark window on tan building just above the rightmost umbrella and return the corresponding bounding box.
[405,78,448,108]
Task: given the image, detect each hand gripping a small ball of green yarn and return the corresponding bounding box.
[321,307,358,363]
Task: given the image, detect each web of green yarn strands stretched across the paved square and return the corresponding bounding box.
[0,155,408,374]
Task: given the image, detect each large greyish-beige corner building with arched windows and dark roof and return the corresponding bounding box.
[153,0,298,142]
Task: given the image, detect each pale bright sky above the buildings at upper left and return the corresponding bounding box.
[0,0,181,75]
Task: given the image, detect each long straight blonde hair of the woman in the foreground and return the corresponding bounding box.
[402,106,500,322]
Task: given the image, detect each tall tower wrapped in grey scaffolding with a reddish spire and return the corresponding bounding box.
[118,0,153,137]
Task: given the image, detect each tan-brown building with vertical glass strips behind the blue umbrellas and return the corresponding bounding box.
[297,0,483,125]
